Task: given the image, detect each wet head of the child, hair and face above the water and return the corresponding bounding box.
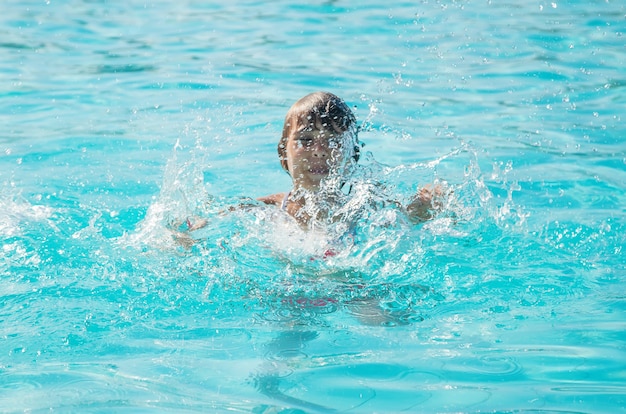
[278,92,360,189]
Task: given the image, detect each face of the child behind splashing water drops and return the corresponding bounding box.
[286,120,345,191]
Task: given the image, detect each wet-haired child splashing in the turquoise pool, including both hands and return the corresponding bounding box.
[176,92,441,325]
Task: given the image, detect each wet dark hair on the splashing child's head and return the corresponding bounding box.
[278,92,361,172]
